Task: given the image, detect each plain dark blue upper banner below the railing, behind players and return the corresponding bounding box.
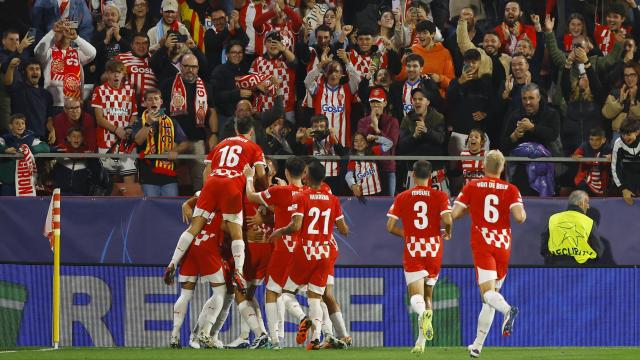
[0,197,640,266]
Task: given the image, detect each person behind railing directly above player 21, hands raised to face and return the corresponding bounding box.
[296,115,346,195]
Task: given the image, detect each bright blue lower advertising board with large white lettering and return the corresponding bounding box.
[0,264,640,348]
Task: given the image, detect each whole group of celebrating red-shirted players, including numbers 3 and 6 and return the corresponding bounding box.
[164,118,526,357]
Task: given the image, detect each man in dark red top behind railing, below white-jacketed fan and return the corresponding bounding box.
[53,97,96,152]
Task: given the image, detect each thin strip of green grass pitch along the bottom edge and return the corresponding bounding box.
[0,347,640,360]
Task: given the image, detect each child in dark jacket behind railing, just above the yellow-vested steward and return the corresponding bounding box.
[571,127,611,196]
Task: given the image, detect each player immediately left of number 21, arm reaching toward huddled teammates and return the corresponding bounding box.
[244,157,306,348]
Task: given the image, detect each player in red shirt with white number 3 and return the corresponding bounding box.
[387,160,453,353]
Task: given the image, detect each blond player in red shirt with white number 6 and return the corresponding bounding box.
[452,150,527,357]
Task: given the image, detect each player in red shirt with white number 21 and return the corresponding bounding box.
[271,161,349,350]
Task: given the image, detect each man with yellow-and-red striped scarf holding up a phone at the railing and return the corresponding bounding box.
[135,90,189,196]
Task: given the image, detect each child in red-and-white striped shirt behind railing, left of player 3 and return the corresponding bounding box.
[345,132,393,197]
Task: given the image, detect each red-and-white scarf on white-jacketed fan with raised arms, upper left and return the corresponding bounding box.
[49,46,82,98]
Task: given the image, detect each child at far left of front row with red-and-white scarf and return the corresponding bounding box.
[0,113,49,196]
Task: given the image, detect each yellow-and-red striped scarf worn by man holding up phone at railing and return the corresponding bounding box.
[140,110,176,176]
